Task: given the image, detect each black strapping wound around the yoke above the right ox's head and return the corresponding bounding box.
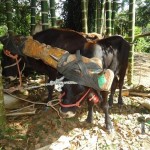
[57,51,103,91]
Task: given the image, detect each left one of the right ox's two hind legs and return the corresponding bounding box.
[109,77,118,107]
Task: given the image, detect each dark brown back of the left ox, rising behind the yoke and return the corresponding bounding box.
[33,28,87,54]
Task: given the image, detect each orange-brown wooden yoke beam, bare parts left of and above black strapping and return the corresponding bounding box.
[23,37,102,69]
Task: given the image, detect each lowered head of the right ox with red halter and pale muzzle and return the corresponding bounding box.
[60,83,100,118]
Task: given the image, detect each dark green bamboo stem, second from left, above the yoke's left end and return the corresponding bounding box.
[31,0,36,35]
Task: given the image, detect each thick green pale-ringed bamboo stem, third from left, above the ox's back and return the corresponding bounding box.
[41,0,48,30]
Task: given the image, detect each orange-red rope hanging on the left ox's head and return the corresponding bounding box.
[4,50,22,87]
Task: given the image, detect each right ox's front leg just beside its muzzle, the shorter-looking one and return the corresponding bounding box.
[86,100,94,123]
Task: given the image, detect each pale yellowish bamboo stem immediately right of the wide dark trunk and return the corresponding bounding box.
[81,0,88,33]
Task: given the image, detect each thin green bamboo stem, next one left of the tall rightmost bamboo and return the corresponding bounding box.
[111,0,117,35]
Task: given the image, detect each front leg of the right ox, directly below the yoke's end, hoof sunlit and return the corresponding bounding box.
[101,92,113,131]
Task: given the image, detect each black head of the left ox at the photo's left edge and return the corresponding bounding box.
[0,36,25,80]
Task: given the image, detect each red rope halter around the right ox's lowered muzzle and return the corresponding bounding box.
[59,88,91,108]
